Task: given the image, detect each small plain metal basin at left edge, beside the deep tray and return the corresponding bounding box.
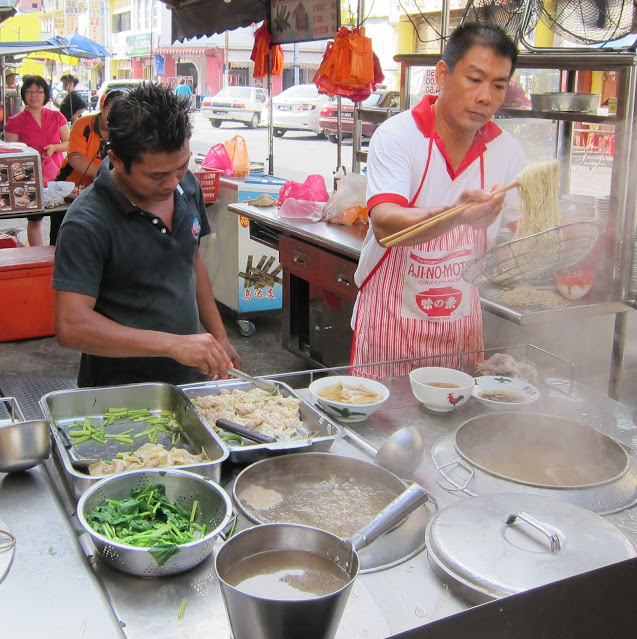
[0,419,51,473]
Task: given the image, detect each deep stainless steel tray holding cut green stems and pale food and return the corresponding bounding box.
[40,383,228,500]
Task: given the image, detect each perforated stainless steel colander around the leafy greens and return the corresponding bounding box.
[77,468,232,577]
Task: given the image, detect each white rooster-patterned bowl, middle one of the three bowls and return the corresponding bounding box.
[409,366,475,413]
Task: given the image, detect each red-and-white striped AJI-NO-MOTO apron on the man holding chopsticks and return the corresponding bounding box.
[351,136,487,379]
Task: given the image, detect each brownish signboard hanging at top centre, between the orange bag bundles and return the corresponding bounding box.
[268,0,341,44]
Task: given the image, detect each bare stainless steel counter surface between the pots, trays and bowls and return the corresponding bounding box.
[0,358,637,639]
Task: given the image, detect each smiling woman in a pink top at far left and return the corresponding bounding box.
[4,75,69,246]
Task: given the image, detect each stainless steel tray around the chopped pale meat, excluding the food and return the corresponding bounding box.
[180,379,344,464]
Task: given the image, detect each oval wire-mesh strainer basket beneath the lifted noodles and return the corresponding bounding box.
[462,221,600,286]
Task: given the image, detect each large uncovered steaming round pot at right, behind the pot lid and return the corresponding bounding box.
[431,412,637,514]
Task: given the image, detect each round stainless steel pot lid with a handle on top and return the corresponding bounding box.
[426,494,637,602]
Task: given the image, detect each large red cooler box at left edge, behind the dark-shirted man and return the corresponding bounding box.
[0,246,55,342]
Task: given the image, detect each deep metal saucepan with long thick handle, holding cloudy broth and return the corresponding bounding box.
[215,484,428,639]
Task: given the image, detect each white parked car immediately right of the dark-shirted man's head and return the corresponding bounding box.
[201,86,268,129]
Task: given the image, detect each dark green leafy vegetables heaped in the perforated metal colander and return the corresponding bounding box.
[86,483,206,566]
